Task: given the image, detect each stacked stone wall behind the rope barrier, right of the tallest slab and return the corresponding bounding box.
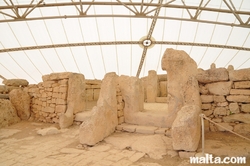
[197,64,250,134]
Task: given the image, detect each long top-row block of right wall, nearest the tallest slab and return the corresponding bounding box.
[196,68,229,83]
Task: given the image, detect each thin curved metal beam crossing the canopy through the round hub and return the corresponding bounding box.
[0,41,250,53]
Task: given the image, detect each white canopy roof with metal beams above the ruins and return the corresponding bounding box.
[0,0,250,83]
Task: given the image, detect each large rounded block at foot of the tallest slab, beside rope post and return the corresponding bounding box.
[171,105,201,151]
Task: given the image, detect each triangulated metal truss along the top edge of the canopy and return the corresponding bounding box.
[0,0,250,28]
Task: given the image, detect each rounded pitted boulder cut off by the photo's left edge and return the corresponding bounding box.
[0,99,20,128]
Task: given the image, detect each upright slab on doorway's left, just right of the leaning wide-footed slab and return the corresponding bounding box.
[119,75,144,124]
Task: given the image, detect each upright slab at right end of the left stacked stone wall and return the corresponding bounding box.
[57,73,85,128]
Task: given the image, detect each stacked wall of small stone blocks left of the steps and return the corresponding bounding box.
[28,72,71,123]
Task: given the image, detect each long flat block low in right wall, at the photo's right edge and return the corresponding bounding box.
[223,114,250,123]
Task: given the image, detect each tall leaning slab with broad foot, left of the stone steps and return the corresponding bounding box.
[79,73,118,145]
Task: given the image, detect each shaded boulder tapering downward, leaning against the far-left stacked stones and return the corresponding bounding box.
[9,89,30,120]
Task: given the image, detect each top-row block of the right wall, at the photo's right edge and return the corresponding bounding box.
[229,68,250,81]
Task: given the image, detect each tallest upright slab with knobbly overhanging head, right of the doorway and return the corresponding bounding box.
[161,49,201,127]
